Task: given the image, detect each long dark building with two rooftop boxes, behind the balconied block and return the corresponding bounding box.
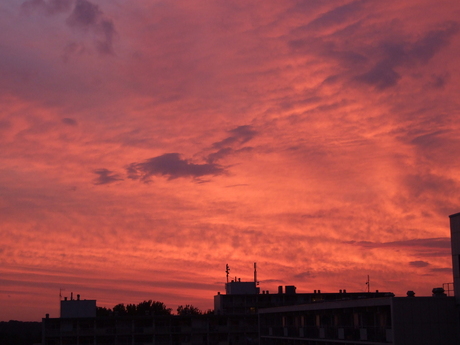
[43,280,393,345]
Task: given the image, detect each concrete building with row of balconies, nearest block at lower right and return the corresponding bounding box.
[259,292,460,345]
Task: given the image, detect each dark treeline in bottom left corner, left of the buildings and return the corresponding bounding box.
[0,320,42,345]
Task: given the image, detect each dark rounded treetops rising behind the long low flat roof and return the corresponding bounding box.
[96,300,213,316]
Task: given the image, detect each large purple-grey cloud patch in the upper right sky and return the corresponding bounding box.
[287,16,460,90]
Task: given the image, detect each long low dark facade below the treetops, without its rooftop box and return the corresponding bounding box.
[43,314,258,345]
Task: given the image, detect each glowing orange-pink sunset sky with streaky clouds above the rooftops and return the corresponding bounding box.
[0,0,460,321]
